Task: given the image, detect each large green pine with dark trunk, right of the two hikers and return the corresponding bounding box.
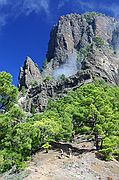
[74,84,119,153]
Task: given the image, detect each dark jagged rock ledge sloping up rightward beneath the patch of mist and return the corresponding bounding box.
[24,70,93,113]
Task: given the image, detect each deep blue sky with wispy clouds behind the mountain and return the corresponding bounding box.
[0,0,119,85]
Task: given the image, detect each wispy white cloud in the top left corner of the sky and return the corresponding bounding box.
[0,0,50,29]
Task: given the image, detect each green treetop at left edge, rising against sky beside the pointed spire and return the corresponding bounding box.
[0,72,17,111]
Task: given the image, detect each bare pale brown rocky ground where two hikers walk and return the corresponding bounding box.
[0,142,119,180]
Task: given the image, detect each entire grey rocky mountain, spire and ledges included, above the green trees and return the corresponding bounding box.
[19,13,119,112]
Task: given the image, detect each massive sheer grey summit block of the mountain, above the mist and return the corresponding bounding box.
[45,12,119,75]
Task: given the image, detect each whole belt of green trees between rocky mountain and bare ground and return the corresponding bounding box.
[0,70,119,173]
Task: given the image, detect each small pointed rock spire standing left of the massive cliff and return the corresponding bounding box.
[18,56,42,90]
